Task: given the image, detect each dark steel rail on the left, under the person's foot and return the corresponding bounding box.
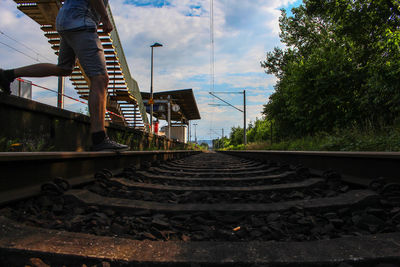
[0,150,199,205]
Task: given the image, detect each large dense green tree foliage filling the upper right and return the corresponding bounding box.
[261,0,400,136]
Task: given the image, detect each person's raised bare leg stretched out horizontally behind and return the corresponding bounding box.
[14,63,71,77]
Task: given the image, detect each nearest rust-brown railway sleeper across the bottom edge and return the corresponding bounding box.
[0,216,400,267]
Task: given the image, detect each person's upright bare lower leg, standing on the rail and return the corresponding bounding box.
[89,74,108,133]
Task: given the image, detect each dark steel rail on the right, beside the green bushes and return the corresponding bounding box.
[219,150,400,186]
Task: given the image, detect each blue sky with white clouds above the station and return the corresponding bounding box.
[0,0,302,139]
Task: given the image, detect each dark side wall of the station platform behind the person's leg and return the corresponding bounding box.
[0,94,184,151]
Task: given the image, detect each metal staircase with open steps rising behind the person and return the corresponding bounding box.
[14,0,149,131]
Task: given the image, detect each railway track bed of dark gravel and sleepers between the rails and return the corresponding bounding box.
[0,152,400,267]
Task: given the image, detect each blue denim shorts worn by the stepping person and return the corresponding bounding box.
[57,29,107,77]
